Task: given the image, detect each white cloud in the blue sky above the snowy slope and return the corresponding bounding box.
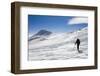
[68,17,88,25]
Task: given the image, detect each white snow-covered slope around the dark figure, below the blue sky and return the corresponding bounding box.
[28,27,88,61]
